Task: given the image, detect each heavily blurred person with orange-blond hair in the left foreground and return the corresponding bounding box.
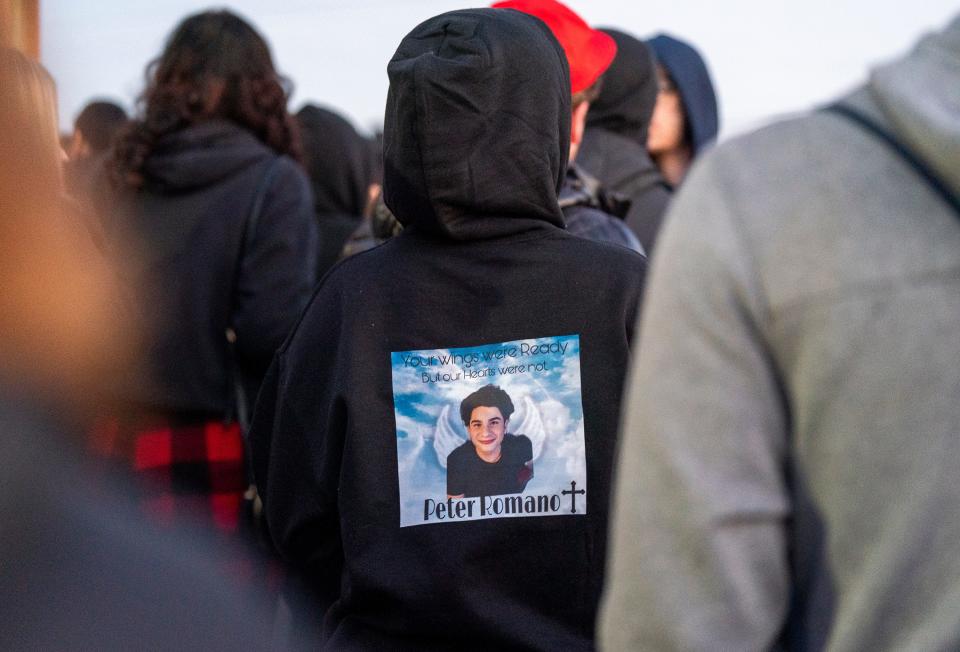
[0,49,278,651]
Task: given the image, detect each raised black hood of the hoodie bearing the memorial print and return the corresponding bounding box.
[383,9,570,240]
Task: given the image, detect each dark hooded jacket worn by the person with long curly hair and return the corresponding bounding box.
[108,121,317,419]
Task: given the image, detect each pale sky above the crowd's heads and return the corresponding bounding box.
[41,0,960,137]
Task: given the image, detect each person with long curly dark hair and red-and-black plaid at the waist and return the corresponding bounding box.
[101,11,318,531]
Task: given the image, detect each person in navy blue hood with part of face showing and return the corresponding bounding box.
[647,34,719,187]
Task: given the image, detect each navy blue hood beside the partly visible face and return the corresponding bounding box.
[647,34,720,156]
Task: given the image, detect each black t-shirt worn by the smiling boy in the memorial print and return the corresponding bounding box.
[447,433,533,497]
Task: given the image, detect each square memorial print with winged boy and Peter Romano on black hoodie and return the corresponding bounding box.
[391,335,587,527]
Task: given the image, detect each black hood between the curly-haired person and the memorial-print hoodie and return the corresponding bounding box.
[297,105,376,275]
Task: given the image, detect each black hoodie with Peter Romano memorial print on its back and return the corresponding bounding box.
[252,9,645,650]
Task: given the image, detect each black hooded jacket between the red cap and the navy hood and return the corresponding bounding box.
[577,29,670,252]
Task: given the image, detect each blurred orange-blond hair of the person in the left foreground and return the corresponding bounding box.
[0,48,137,408]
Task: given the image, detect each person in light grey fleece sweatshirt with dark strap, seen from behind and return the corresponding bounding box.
[599,18,960,650]
